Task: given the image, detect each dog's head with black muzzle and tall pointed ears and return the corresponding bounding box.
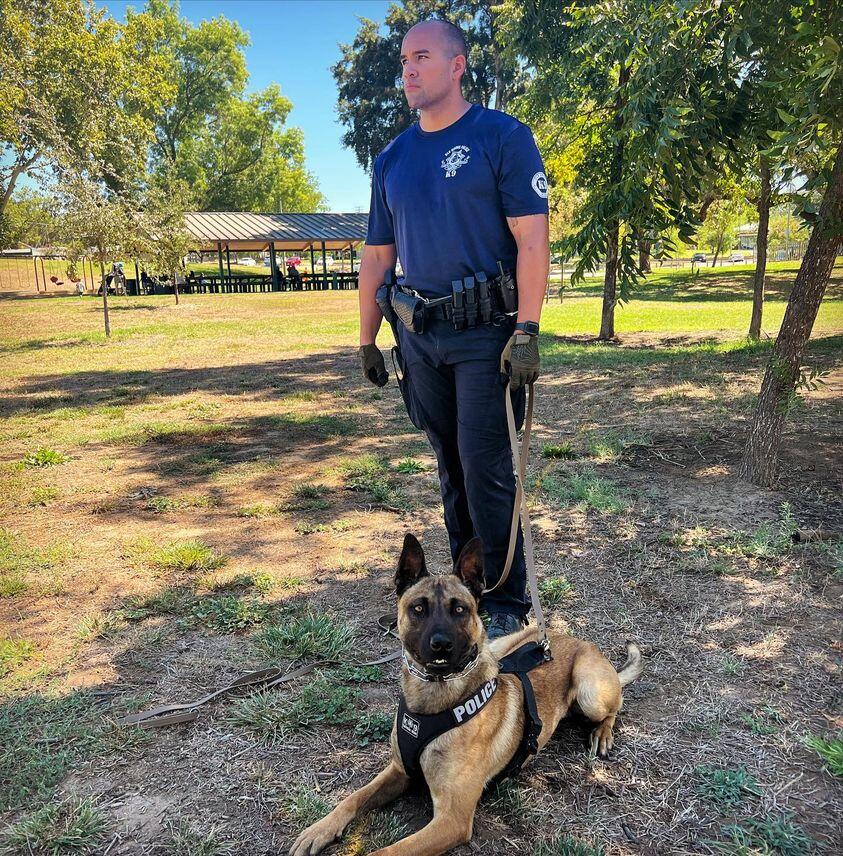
[395,533,485,675]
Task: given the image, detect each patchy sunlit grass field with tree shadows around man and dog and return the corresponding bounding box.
[0,263,843,856]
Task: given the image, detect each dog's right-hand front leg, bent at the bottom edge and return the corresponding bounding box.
[371,776,483,856]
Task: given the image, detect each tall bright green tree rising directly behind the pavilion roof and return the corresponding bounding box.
[143,0,325,211]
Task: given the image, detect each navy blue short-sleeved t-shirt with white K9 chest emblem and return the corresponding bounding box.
[366,104,547,297]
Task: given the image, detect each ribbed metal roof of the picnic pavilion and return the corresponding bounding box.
[185,211,369,252]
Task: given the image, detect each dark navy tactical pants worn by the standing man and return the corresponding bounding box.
[399,320,530,618]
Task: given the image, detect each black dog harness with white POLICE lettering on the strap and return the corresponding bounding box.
[396,642,549,783]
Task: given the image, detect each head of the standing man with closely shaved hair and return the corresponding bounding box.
[401,21,467,110]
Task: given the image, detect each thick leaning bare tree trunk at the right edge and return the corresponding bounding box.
[739,143,843,487]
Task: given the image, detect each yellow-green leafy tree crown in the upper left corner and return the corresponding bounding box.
[0,0,172,217]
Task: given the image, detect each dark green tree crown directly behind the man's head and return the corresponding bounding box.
[331,0,525,170]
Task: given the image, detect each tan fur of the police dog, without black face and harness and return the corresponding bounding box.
[289,552,641,856]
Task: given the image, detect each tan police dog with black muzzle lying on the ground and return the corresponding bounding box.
[289,533,642,856]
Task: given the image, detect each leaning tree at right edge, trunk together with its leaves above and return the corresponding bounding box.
[737,0,843,486]
